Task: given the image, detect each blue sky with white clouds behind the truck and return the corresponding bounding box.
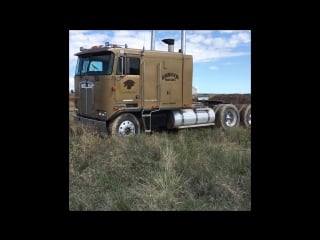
[69,30,251,94]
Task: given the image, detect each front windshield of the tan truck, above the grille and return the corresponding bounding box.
[75,52,114,76]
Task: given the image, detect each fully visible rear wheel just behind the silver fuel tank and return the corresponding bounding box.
[216,104,240,130]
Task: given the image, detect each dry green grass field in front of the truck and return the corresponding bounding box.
[69,114,251,211]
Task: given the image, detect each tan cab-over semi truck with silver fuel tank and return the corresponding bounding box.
[74,36,251,136]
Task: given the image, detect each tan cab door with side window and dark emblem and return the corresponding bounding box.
[115,56,140,107]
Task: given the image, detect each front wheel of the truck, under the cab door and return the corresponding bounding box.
[109,113,140,137]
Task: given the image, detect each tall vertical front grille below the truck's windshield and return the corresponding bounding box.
[80,81,94,115]
